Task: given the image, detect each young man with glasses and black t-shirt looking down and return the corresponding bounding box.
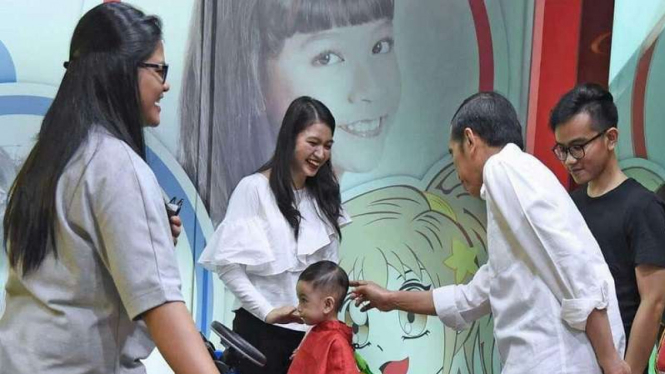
[550,84,665,374]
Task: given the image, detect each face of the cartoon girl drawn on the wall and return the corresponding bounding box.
[339,265,444,374]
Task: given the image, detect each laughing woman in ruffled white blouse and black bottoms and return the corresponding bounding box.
[199,97,350,374]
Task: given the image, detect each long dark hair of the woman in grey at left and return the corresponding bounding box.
[3,2,162,275]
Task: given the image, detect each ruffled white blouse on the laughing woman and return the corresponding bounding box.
[199,173,351,331]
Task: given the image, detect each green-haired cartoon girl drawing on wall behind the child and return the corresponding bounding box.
[340,185,498,374]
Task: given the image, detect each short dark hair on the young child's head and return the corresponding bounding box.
[298,261,349,312]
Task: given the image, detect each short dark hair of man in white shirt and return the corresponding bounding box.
[450,92,524,149]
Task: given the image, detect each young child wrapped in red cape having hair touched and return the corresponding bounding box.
[289,261,359,374]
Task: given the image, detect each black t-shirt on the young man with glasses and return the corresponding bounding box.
[571,179,665,338]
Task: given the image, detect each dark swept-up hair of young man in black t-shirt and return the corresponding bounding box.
[550,83,619,131]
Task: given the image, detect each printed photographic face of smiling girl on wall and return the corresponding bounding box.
[266,19,401,177]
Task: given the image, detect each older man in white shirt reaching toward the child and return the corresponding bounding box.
[351,92,630,374]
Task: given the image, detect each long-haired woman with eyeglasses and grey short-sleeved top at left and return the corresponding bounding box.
[0,3,218,374]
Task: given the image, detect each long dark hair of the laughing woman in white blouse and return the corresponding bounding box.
[259,96,342,238]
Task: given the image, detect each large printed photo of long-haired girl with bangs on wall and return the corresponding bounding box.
[179,0,401,224]
